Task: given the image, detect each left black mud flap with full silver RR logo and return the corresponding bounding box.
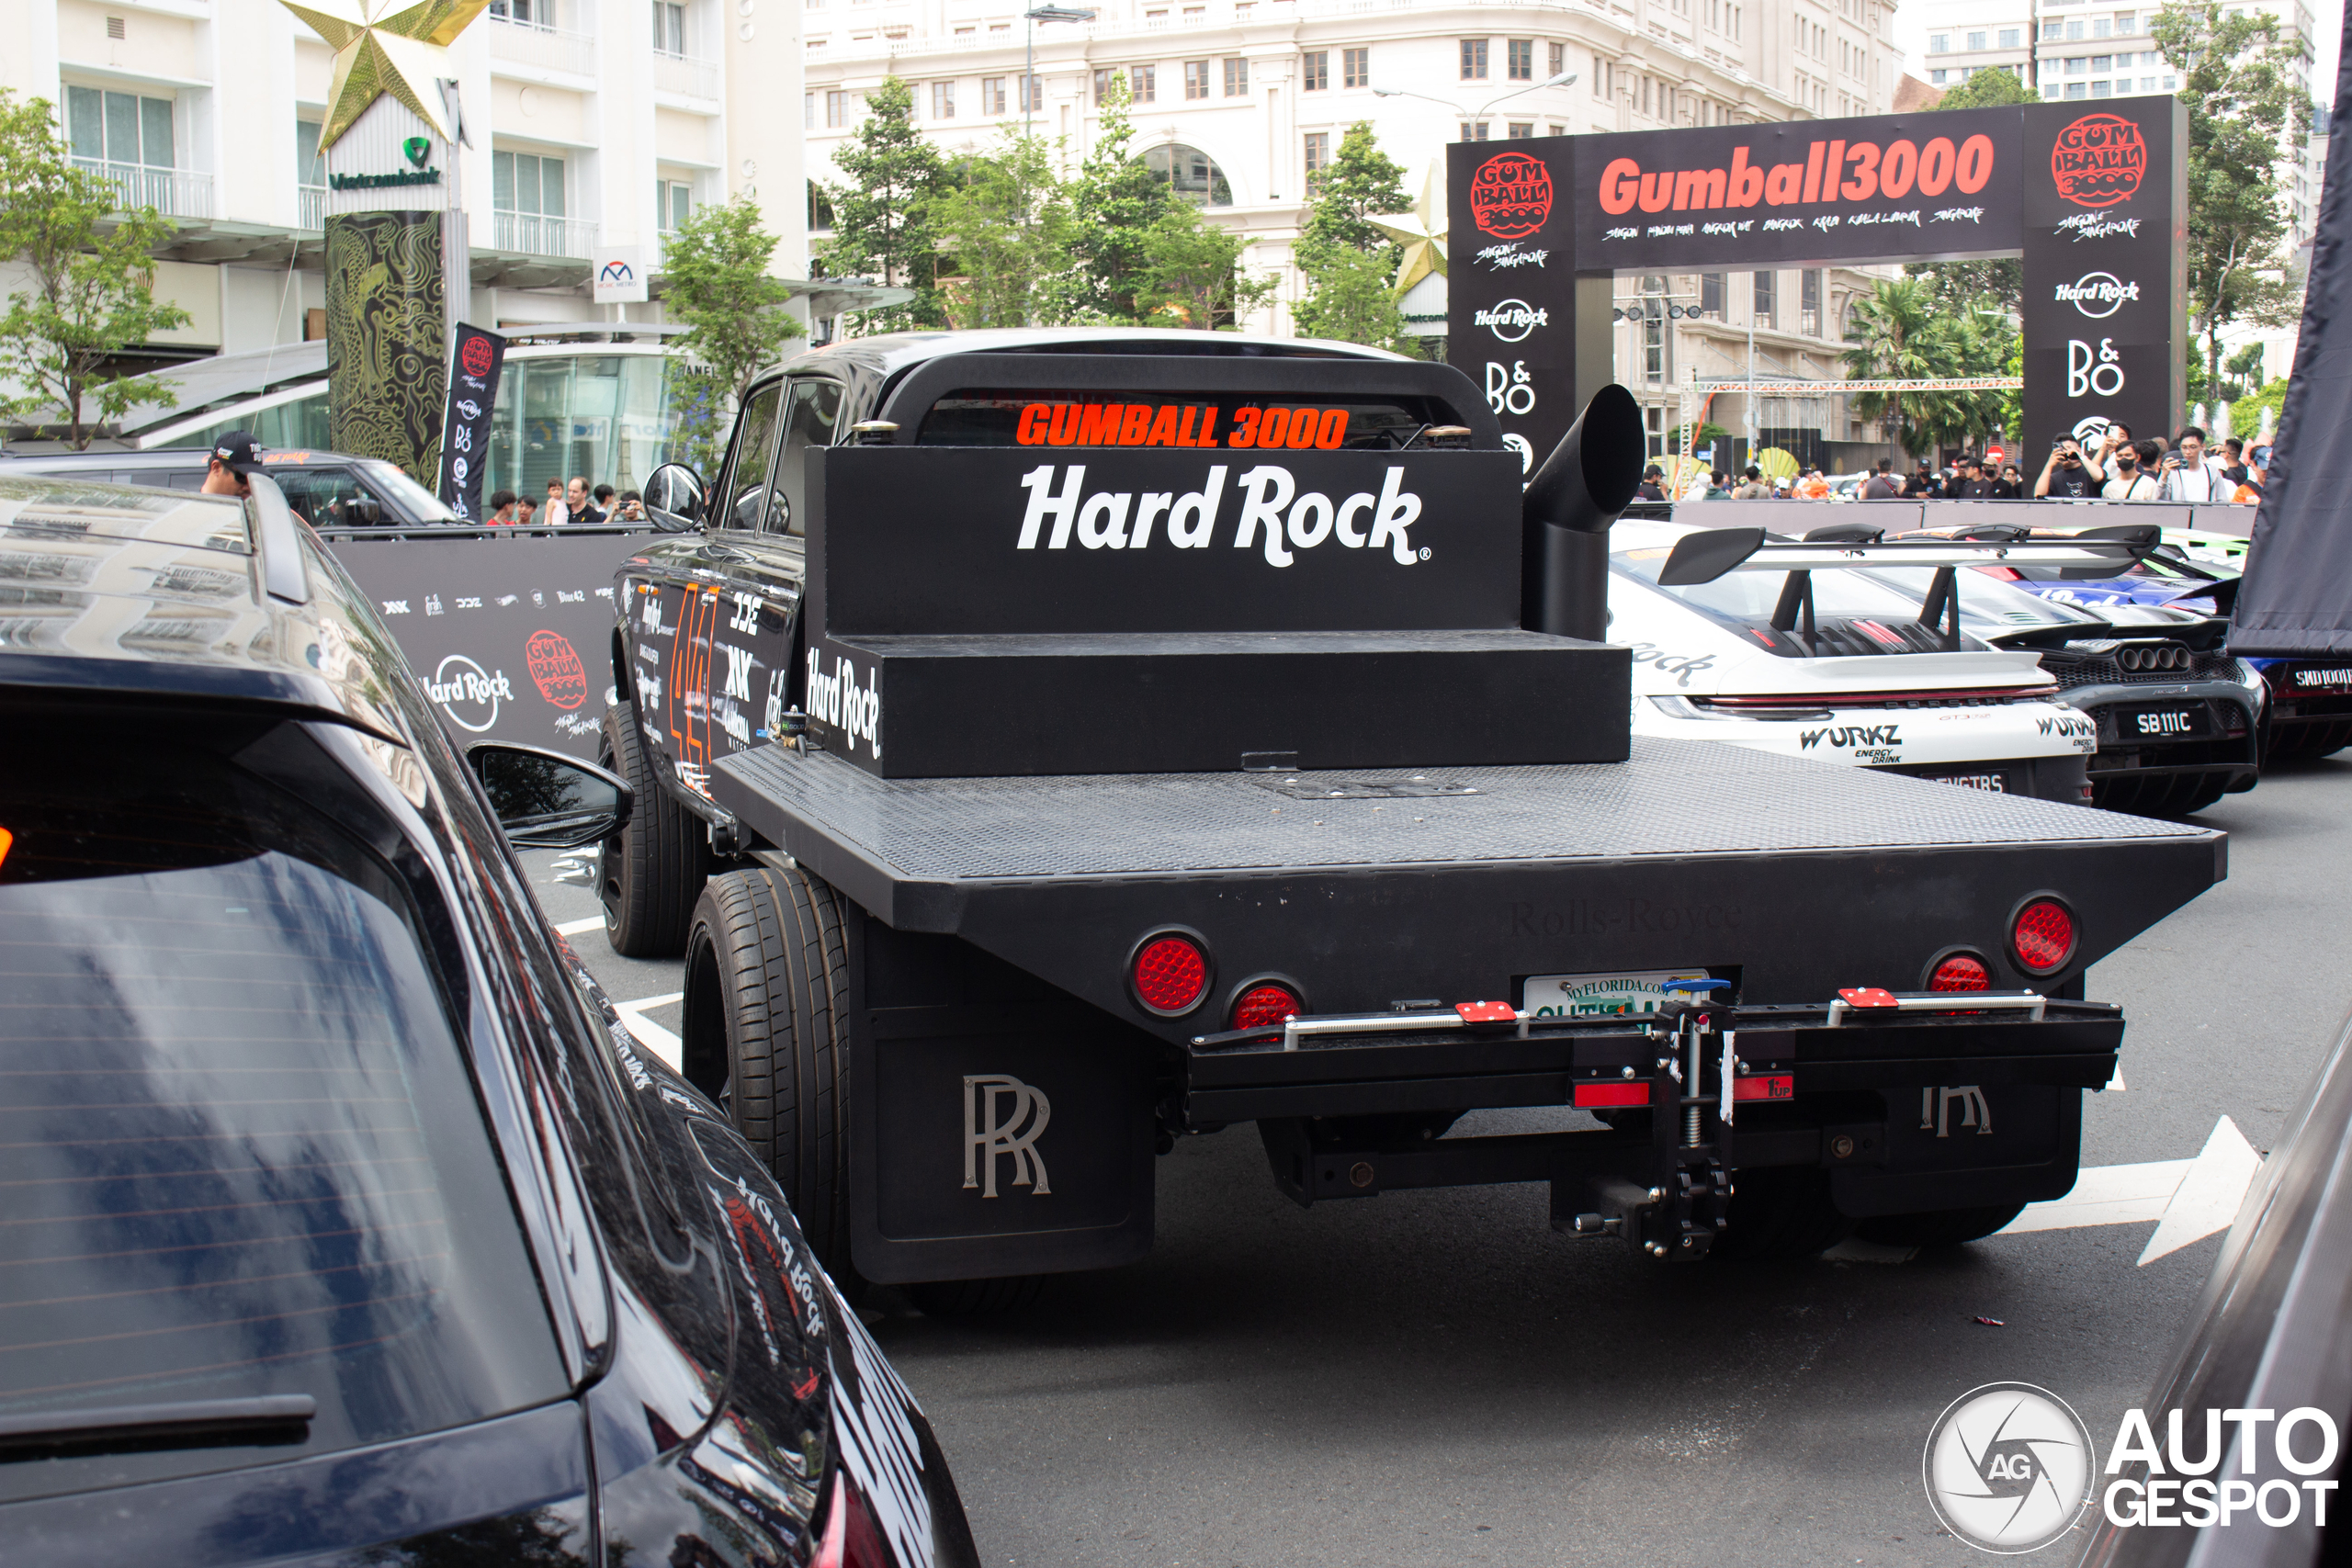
[849,917,1162,1283]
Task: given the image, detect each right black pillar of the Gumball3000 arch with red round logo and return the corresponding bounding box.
[2018,96,2189,460]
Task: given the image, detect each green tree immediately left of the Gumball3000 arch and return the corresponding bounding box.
[1291,120,1420,357]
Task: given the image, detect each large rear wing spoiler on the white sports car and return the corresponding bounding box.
[1658,525,2162,653]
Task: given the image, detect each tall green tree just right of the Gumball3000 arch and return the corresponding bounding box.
[2150,0,2312,404]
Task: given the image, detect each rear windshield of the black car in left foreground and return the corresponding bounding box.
[0,748,564,1497]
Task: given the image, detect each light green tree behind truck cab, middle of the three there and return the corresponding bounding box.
[932,125,1093,327]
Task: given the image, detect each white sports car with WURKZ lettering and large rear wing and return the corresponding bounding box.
[1609,520,2098,804]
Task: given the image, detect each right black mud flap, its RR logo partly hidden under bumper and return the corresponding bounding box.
[1823,1084,2082,1220]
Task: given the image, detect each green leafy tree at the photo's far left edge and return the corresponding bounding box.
[0,87,188,451]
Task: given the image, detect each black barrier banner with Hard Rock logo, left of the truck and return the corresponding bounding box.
[327,529,642,761]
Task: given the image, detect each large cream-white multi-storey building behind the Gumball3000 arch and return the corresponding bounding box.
[802,0,1900,463]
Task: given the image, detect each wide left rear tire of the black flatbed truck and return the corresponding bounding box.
[680,865,852,1286]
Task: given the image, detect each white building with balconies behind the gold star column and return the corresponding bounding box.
[0,0,807,360]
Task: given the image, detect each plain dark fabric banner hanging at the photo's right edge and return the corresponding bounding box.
[2230,3,2352,659]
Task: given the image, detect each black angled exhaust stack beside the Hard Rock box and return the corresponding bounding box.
[1520,383,1649,642]
